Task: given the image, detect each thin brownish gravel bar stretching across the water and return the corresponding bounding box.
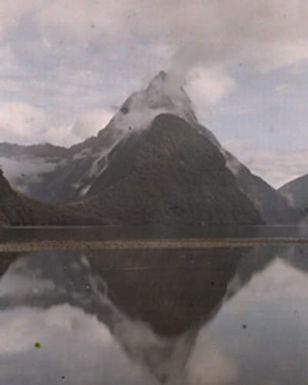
[0,238,308,253]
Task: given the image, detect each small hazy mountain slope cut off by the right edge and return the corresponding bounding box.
[279,174,308,214]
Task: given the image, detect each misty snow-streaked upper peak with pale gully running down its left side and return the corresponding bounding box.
[76,71,198,197]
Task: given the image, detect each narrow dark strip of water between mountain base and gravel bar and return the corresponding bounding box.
[0,225,308,242]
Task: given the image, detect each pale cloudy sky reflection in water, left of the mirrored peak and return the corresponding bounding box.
[0,304,154,385]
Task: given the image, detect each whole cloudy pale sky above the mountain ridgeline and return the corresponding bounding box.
[0,0,308,186]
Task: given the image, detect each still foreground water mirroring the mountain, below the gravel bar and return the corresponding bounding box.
[0,246,308,385]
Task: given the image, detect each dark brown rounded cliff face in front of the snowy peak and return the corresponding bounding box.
[76,114,262,224]
